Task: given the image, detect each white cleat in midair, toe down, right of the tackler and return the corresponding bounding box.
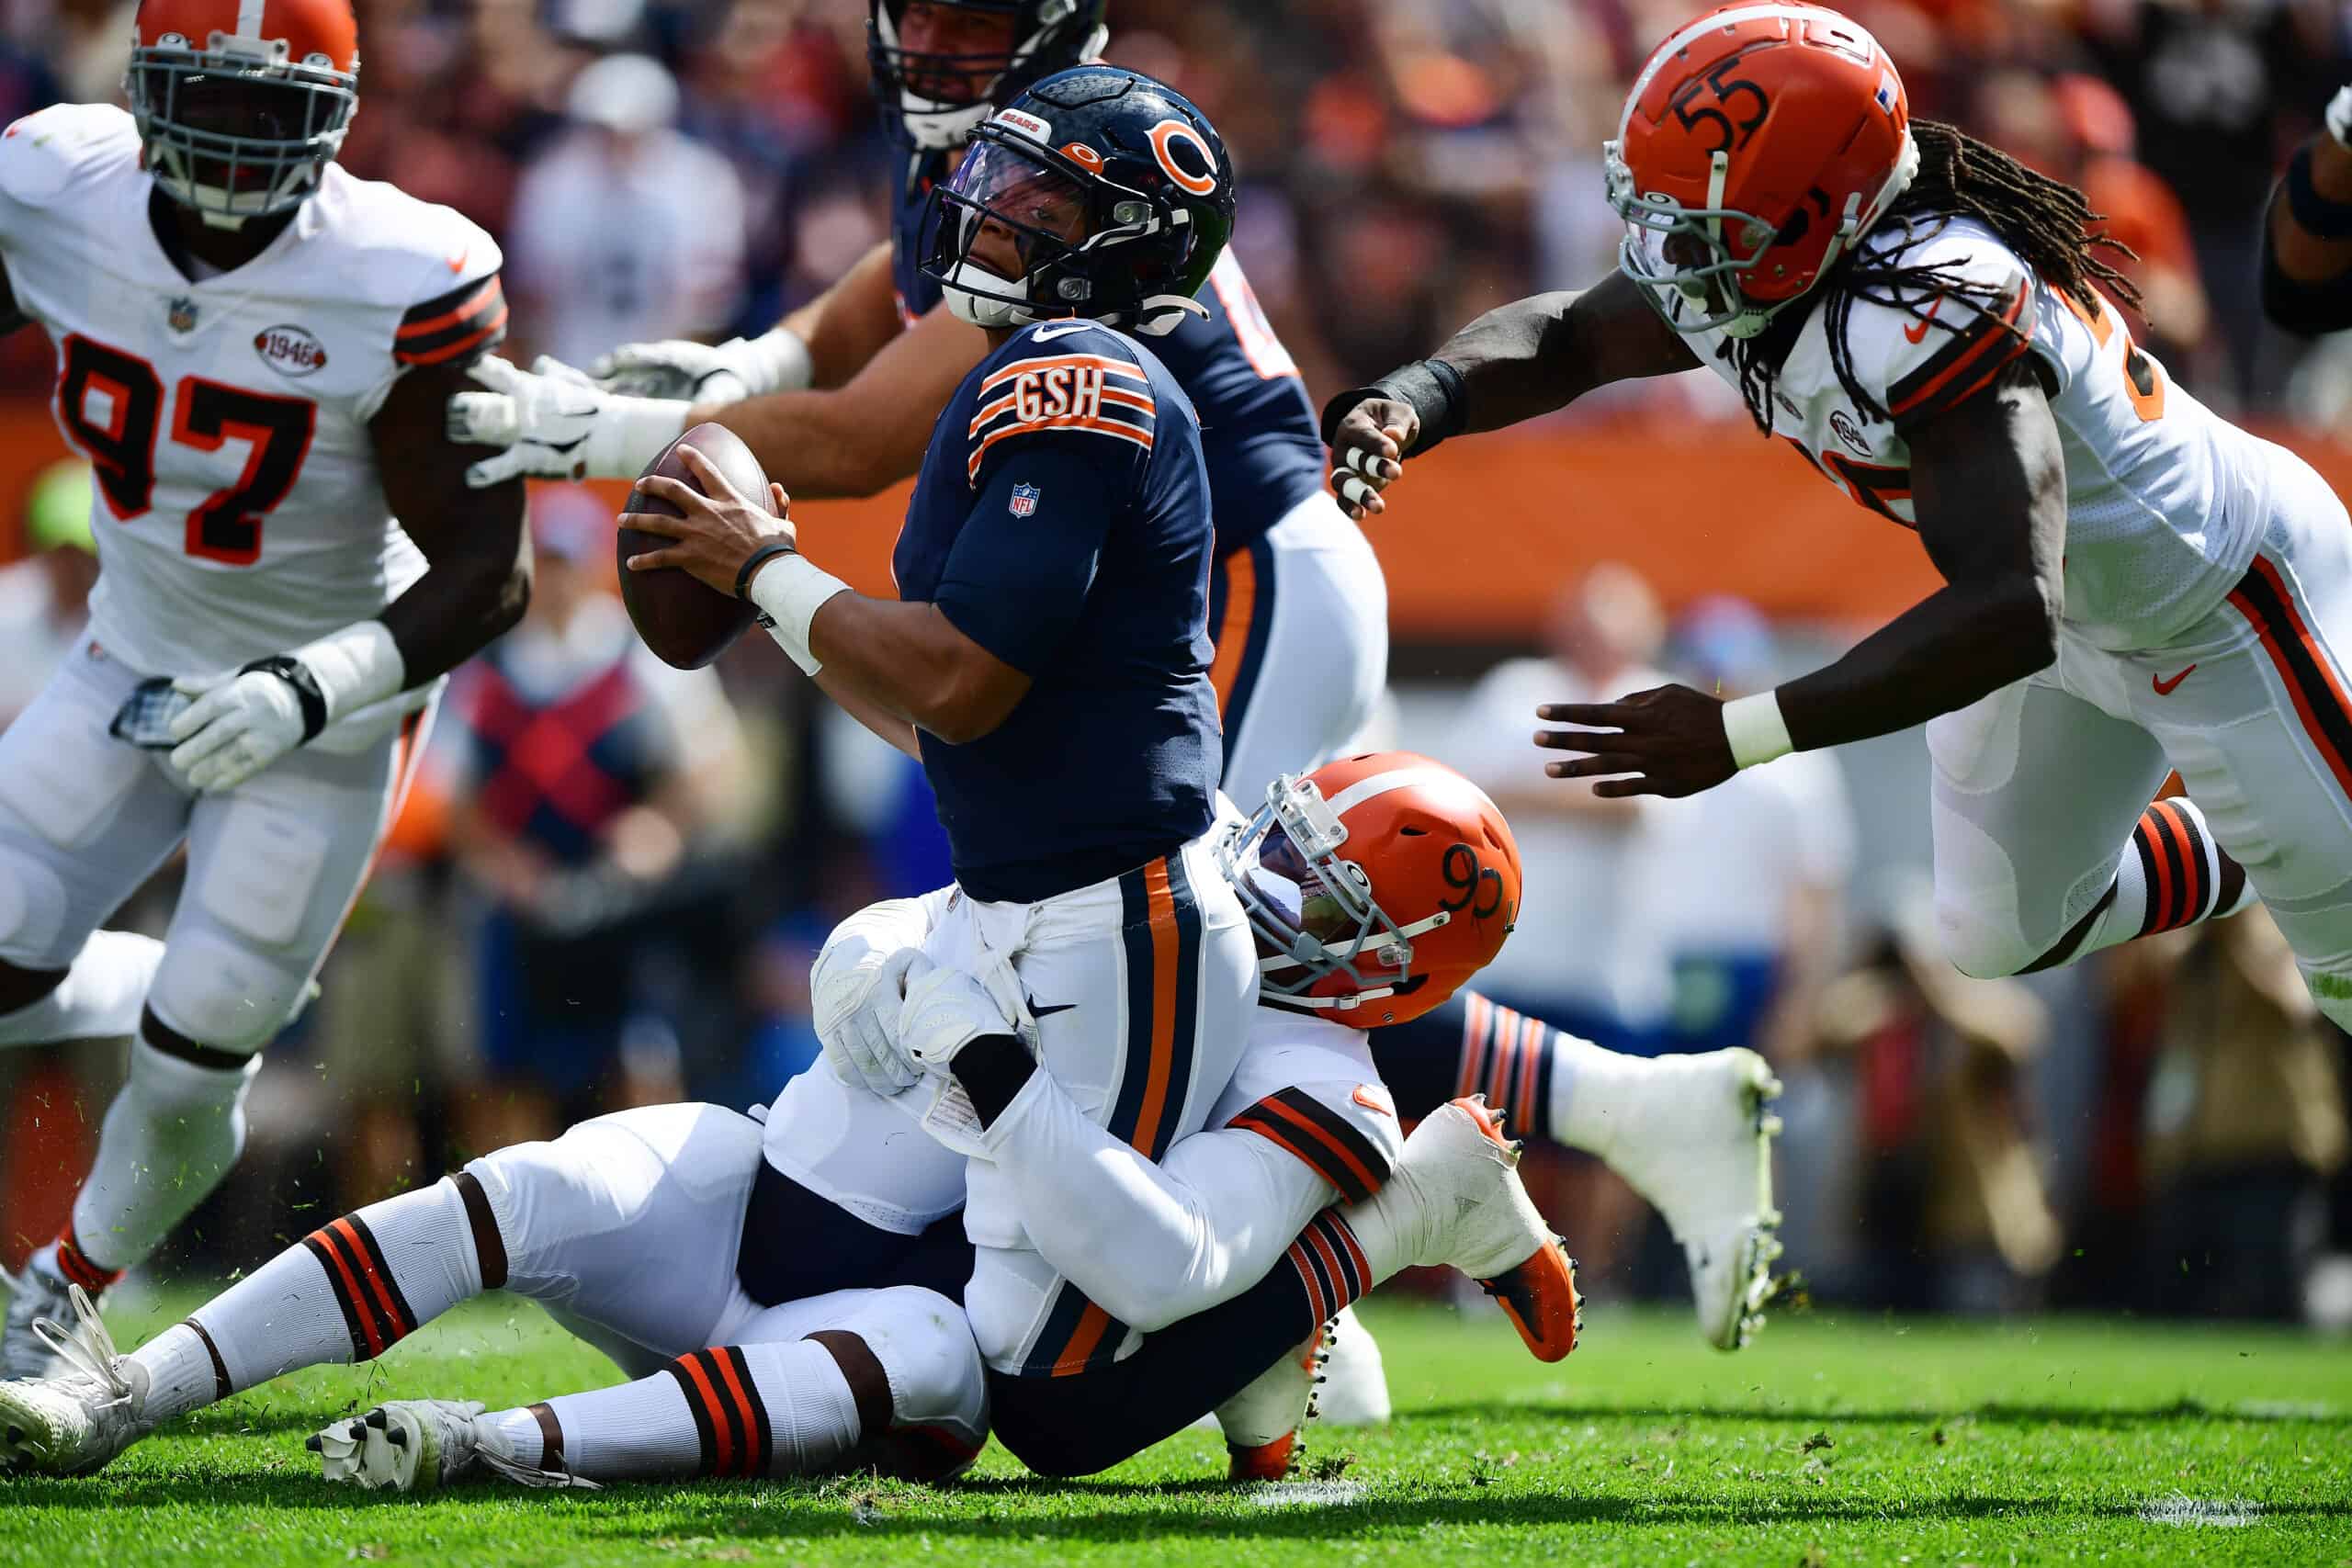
[1606,1048,1781,1349]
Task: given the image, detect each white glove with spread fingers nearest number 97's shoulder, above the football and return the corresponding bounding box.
[447,355,687,489]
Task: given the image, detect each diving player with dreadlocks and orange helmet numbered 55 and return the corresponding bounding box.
[1324,3,2352,1022]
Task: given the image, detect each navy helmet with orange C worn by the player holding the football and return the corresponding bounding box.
[922,63,1232,333]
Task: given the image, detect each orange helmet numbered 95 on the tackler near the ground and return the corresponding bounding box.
[1221,752,1520,1030]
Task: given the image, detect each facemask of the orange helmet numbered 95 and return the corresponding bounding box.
[1216,776,1453,1013]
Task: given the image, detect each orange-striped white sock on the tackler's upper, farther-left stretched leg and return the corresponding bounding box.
[131,1178,503,1420]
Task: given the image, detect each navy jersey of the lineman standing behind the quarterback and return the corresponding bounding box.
[891,152,1324,555]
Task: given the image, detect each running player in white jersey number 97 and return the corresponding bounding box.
[0,0,529,1375]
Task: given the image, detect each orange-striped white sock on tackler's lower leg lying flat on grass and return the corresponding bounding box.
[534,1340,861,1481]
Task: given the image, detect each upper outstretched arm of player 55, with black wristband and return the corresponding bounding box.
[1324,273,1698,517]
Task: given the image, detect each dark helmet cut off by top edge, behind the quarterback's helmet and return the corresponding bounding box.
[865,0,1110,151]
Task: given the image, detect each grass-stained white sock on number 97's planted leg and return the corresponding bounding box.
[73,1037,261,1269]
